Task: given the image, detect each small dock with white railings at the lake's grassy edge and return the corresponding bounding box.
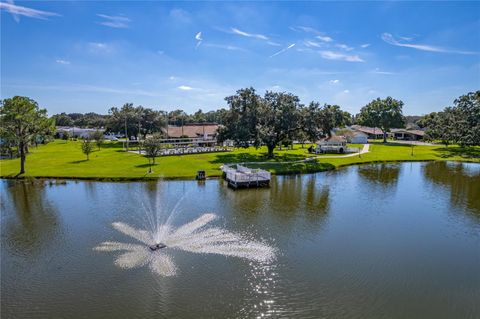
[221,164,272,188]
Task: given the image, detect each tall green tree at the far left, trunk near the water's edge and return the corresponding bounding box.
[0,96,55,175]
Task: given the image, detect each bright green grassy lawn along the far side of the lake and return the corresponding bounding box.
[0,140,480,180]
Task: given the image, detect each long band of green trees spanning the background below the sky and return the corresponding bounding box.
[0,87,480,174]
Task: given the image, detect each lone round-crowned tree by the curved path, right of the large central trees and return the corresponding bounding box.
[357,96,405,143]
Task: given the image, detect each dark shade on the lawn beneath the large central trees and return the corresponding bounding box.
[210,152,305,164]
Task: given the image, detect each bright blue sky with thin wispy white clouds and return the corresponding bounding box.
[0,0,480,114]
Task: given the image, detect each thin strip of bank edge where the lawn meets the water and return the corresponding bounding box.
[0,159,480,182]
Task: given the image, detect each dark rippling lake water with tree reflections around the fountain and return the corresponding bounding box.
[0,162,480,318]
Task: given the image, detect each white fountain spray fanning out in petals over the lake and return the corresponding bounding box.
[94,212,275,276]
